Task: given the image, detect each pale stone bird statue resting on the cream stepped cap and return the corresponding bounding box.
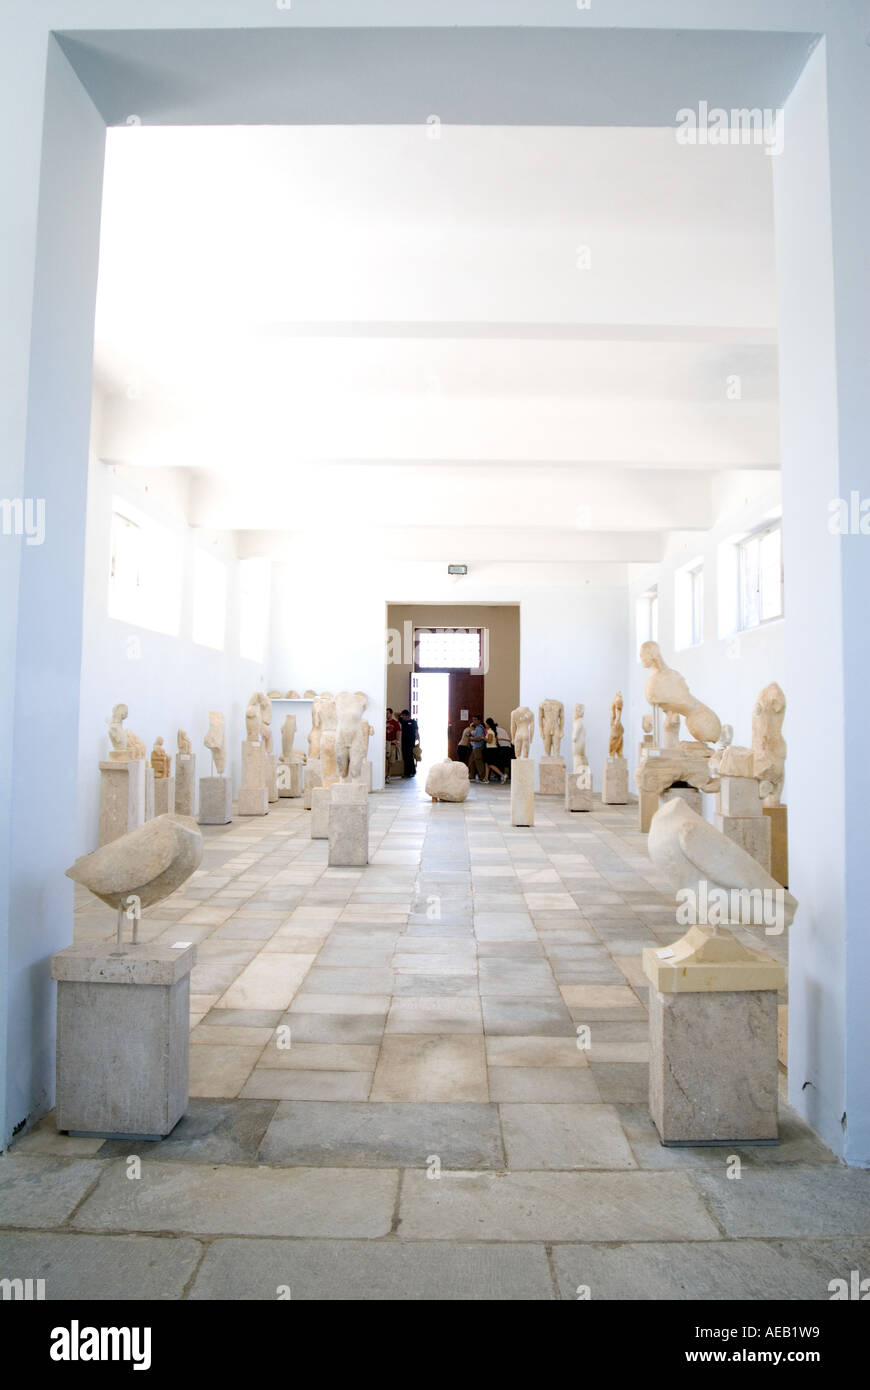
[648,796,798,926]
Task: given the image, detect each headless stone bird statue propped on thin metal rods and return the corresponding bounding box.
[67,815,203,919]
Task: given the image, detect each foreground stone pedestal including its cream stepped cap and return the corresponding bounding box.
[643,927,785,1144]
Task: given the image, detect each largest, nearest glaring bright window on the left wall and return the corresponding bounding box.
[108,499,183,637]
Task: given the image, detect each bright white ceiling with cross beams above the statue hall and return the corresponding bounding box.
[95,125,778,574]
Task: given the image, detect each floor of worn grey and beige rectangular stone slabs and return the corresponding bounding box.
[0,781,870,1300]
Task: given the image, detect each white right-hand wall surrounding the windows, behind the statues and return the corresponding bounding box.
[624,473,789,817]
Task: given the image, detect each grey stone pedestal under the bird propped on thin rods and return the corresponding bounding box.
[51,941,196,1140]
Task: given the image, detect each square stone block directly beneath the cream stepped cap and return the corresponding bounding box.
[649,988,778,1144]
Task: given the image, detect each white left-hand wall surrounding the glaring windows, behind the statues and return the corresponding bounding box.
[76,396,268,853]
